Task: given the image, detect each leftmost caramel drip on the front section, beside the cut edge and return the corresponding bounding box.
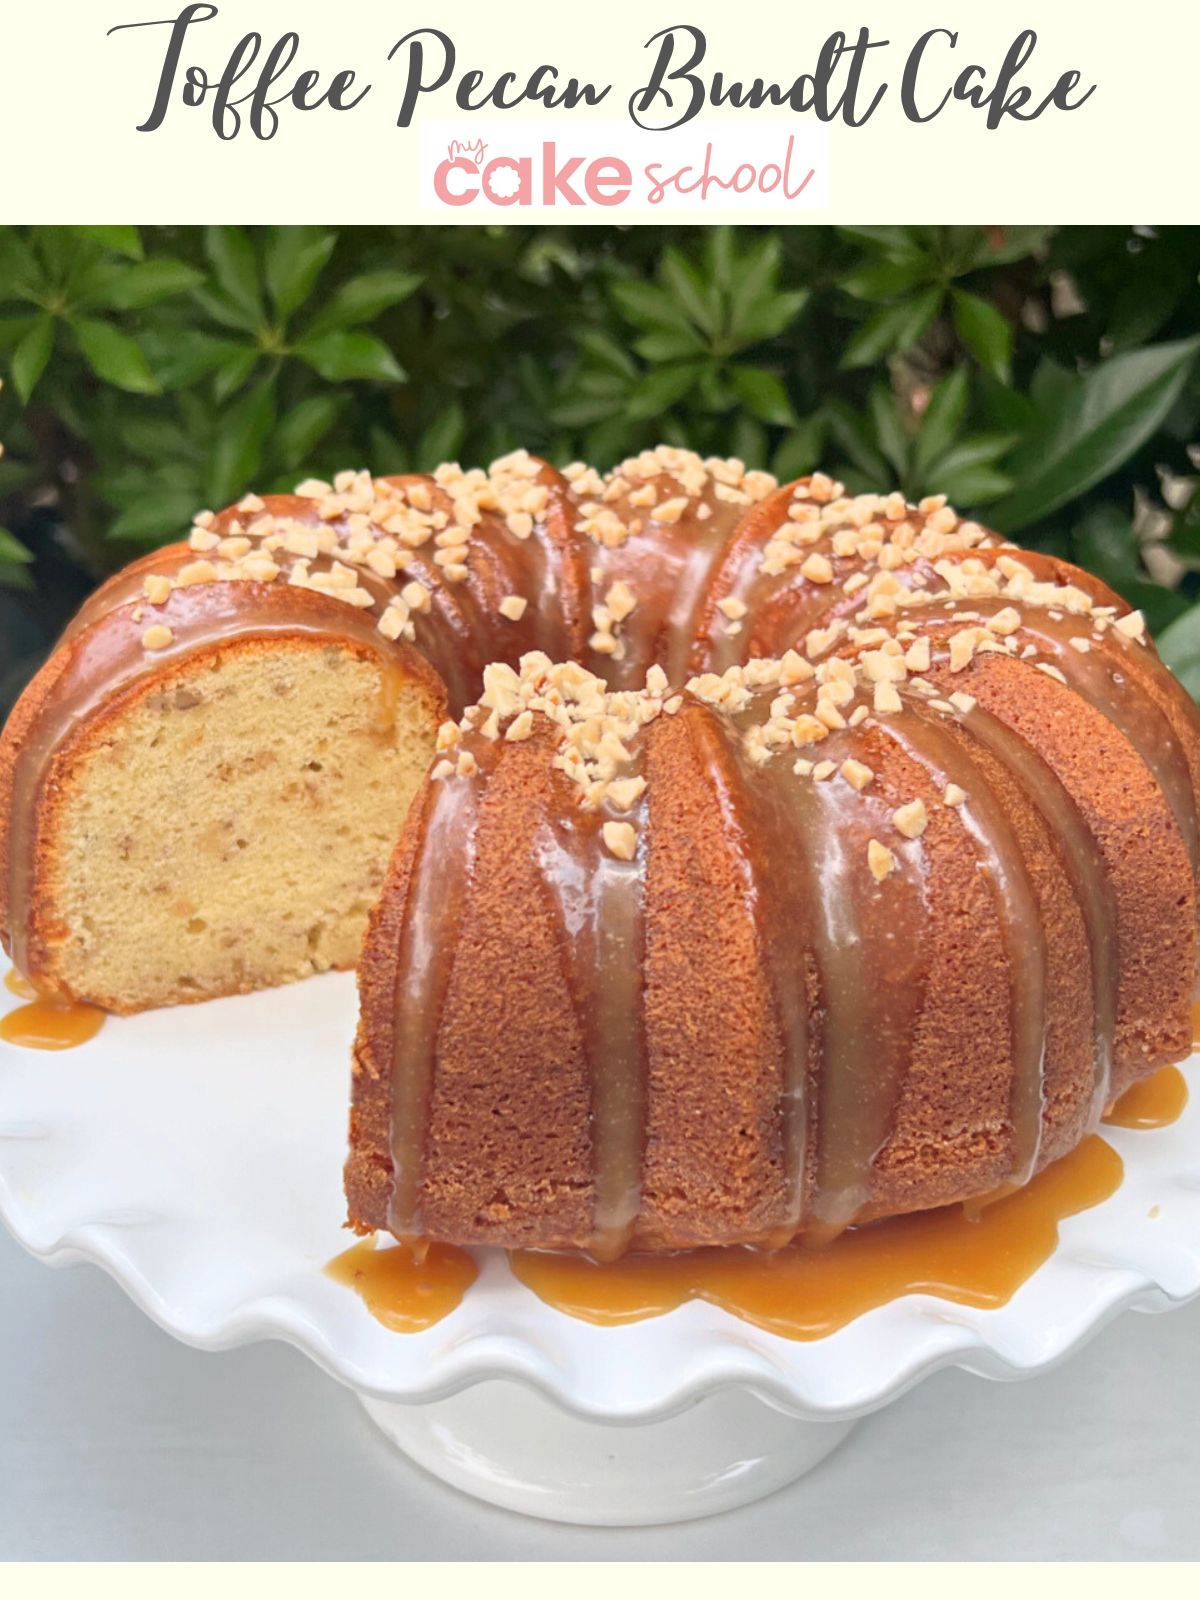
[387,776,480,1243]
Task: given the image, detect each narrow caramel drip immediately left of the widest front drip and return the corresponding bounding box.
[694,715,813,1245]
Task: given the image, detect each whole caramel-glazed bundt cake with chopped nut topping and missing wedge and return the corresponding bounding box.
[0,448,1200,1256]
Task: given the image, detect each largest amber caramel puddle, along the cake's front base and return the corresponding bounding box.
[510,1136,1123,1339]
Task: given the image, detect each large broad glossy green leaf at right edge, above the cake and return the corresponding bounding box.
[990,338,1200,533]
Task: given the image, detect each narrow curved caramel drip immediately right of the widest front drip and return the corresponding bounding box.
[878,698,1048,1186]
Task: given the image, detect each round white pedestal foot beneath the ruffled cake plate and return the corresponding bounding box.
[360,1379,854,1526]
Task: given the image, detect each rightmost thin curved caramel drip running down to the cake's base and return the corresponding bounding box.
[960,706,1120,1125]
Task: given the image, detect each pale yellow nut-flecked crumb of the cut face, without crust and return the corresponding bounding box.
[30,638,437,1011]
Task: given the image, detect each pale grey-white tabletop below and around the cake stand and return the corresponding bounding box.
[0,1232,1200,1560]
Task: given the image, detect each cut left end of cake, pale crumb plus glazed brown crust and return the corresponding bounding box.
[0,584,445,1013]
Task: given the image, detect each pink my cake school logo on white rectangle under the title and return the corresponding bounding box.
[421,118,827,211]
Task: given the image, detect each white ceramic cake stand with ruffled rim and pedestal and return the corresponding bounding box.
[0,976,1200,1523]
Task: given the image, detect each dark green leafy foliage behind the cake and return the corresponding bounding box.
[0,227,1200,710]
